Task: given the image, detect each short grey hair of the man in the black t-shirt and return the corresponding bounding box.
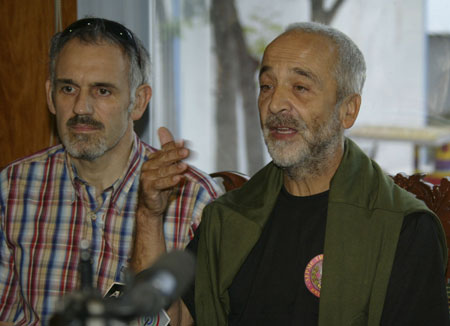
[283,22,366,102]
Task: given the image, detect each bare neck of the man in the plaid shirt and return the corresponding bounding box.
[69,132,133,197]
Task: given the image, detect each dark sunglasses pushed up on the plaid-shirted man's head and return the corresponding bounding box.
[61,18,141,67]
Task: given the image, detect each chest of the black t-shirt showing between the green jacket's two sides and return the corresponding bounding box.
[228,188,328,325]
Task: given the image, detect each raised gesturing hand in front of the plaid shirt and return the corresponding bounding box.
[139,127,189,217]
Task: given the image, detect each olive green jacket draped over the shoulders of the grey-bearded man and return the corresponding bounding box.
[195,139,447,326]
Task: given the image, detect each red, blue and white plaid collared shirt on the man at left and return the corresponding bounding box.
[0,136,221,325]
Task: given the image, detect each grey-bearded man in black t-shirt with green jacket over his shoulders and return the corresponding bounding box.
[183,23,449,326]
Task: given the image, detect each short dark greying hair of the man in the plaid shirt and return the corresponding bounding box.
[49,17,150,102]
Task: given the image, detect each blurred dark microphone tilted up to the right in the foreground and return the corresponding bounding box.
[105,251,195,320]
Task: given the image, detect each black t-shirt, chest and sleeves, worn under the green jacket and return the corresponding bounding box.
[183,187,450,326]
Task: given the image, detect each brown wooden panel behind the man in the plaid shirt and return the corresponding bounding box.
[0,0,77,168]
